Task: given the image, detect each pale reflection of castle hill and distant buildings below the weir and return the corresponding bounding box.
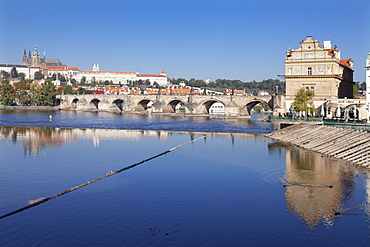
[0,126,255,158]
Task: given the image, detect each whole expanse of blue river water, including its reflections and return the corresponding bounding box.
[0,111,370,246]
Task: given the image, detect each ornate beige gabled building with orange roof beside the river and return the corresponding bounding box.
[284,36,354,109]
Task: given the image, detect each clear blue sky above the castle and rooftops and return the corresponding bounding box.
[0,0,370,82]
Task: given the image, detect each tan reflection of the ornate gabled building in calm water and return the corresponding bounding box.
[282,145,356,228]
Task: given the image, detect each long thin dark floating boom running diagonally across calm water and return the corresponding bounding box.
[0,135,207,219]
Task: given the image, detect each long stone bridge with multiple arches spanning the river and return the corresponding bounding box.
[58,94,279,117]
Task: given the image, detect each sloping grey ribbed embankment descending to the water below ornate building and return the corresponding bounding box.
[266,124,370,168]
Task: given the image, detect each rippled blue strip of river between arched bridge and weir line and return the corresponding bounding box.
[0,111,275,134]
